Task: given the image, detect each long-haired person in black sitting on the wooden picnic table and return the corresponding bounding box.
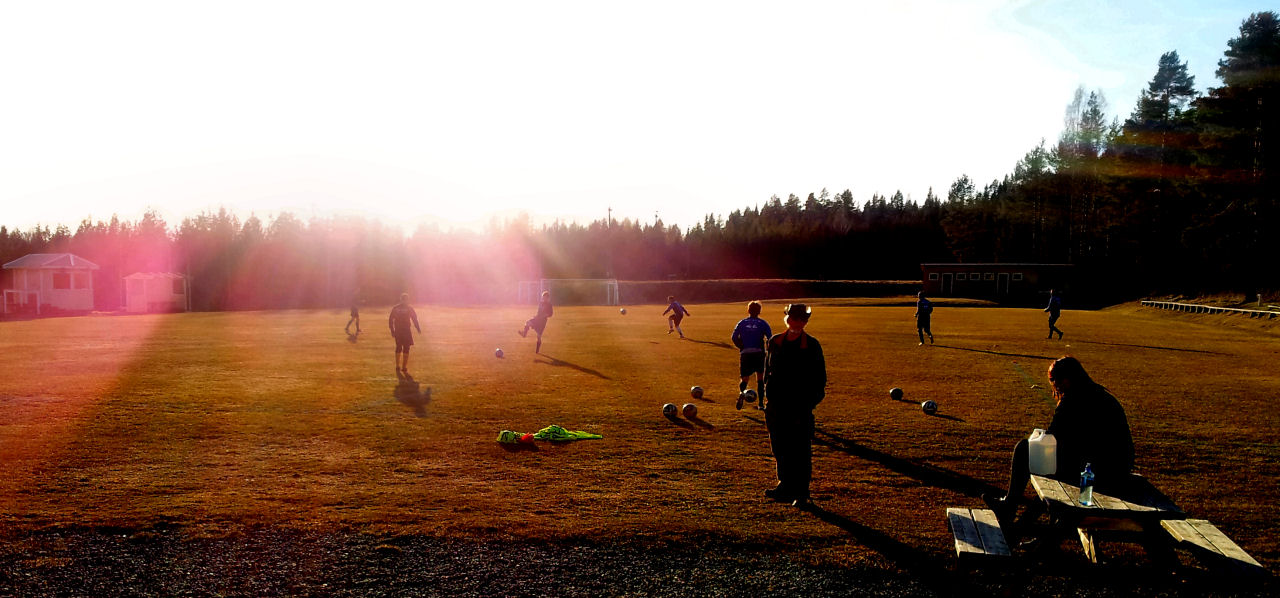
[982,357,1134,519]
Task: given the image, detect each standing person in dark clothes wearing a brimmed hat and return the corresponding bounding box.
[764,303,827,508]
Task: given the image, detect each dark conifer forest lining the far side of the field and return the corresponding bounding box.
[0,12,1280,310]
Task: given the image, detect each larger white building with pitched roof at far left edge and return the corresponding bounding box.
[4,254,97,314]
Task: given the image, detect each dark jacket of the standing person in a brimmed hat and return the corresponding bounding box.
[764,332,827,414]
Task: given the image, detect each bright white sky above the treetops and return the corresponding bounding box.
[0,0,1271,232]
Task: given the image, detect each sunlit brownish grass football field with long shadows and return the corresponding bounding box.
[0,300,1280,591]
